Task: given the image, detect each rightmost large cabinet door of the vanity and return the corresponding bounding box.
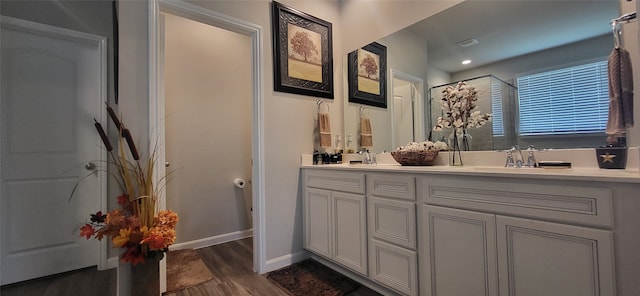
[496,216,616,296]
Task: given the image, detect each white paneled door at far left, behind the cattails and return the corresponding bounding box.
[0,17,106,285]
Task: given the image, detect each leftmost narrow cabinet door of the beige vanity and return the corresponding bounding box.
[303,188,333,258]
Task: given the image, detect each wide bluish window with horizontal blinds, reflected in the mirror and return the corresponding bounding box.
[517,60,609,136]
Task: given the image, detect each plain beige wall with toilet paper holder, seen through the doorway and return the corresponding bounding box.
[164,14,252,244]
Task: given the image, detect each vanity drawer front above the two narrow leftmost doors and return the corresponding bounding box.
[304,170,365,194]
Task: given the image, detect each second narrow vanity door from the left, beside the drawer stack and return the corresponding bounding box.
[331,192,367,275]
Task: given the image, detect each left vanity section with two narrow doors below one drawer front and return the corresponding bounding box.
[303,170,367,276]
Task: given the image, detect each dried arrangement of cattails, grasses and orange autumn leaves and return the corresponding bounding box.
[77,106,178,265]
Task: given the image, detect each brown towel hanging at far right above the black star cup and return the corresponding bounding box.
[606,48,634,143]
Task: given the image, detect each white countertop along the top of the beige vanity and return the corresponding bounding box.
[301,148,640,184]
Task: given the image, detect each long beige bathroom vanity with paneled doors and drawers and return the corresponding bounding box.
[301,156,640,296]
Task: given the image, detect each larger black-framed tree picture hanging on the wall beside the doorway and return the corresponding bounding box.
[272,1,333,99]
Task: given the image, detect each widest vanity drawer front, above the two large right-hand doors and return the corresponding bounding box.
[418,176,613,228]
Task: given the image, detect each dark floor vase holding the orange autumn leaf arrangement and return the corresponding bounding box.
[130,252,164,296]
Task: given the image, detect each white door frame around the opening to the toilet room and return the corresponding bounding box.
[149,0,266,273]
